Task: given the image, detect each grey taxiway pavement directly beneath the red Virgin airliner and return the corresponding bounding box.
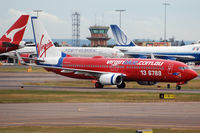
[0,72,200,93]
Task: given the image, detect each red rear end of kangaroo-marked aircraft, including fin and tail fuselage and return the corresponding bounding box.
[0,15,29,53]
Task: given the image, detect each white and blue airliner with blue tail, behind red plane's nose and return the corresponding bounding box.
[110,25,200,62]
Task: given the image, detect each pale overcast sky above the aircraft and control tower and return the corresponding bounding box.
[0,0,200,41]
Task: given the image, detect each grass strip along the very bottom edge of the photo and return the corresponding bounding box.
[0,126,200,133]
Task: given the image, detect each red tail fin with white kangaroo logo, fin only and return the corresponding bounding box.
[0,15,29,45]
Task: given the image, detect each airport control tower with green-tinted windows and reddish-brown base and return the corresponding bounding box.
[87,26,110,47]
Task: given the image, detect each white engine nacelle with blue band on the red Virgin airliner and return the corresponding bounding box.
[99,73,123,85]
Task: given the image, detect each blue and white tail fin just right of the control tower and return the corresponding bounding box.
[110,25,137,46]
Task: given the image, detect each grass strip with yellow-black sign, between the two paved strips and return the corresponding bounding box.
[0,90,200,103]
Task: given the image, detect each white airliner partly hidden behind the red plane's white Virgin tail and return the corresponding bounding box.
[0,47,124,58]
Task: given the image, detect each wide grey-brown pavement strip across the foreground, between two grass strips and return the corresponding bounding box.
[0,102,200,129]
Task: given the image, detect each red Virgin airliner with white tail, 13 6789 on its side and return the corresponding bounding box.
[18,17,197,89]
